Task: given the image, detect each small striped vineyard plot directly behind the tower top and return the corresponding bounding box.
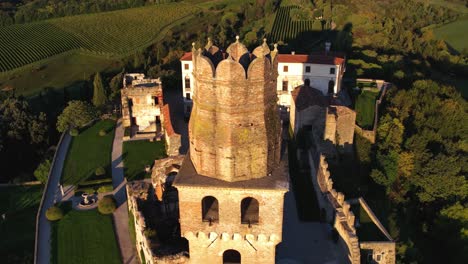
[268,6,320,42]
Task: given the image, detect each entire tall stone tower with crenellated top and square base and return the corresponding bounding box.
[174,37,288,263]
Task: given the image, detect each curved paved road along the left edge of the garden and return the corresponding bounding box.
[36,133,71,264]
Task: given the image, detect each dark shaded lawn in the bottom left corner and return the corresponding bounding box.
[0,185,43,264]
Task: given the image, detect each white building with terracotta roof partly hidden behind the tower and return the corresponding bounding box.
[180,52,345,114]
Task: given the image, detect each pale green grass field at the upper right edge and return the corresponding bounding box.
[434,15,468,52]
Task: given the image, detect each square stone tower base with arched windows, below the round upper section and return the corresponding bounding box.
[178,186,285,264]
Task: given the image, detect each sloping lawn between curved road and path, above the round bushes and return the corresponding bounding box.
[61,119,115,185]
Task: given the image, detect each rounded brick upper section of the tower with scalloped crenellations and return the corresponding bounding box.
[189,40,281,182]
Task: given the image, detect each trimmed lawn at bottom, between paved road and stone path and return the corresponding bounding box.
[51,210,122,264]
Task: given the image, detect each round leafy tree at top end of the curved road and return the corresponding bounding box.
[57,101,98,132]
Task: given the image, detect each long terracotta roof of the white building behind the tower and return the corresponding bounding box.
[180,52,344,65]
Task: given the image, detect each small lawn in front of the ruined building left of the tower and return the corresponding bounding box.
[122,140,166,181]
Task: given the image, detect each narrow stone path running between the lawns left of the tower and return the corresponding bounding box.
[112,119,138,264]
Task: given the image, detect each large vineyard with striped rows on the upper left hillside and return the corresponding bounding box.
[0,3,194,72]
